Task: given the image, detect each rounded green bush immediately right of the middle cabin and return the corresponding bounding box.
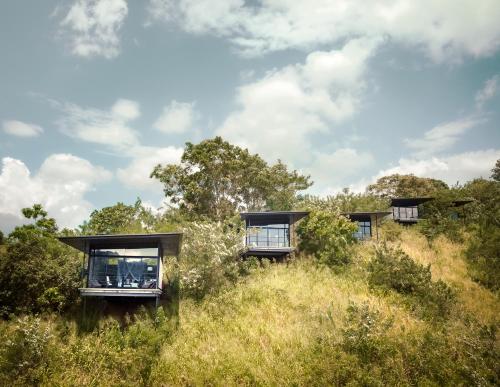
[297,201,357,267]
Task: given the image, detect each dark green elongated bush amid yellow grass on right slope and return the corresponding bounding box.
[368,243,456,319]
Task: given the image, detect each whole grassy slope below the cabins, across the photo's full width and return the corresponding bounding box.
[0,229,500,386]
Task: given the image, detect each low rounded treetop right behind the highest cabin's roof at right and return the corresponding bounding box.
[366,174,448,197]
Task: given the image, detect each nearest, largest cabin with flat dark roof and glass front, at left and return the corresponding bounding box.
[59,233,182,302]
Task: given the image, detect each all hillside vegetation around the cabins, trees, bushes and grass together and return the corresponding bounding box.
[0,138,500,386]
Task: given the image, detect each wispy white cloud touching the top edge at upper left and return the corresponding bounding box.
[61,0,128,59]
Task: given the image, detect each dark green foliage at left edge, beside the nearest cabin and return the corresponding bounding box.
[0,205,79,316]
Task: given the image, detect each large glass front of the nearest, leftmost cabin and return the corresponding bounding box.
[89,248,160,289]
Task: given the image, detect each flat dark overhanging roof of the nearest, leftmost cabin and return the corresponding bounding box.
[58,232,182,255]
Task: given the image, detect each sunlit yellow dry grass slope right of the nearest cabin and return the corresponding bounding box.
[152,230,500,385]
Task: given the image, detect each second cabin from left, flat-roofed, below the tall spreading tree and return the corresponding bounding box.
[240,211,309,258]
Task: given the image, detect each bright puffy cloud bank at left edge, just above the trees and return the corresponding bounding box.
[0,154,111,230]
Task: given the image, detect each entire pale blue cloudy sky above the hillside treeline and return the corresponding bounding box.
[0,0,500,232]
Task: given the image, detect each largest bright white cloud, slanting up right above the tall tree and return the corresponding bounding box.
[216,39,379,165]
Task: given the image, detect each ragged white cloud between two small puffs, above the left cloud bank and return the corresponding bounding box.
[54,99,140,151]
